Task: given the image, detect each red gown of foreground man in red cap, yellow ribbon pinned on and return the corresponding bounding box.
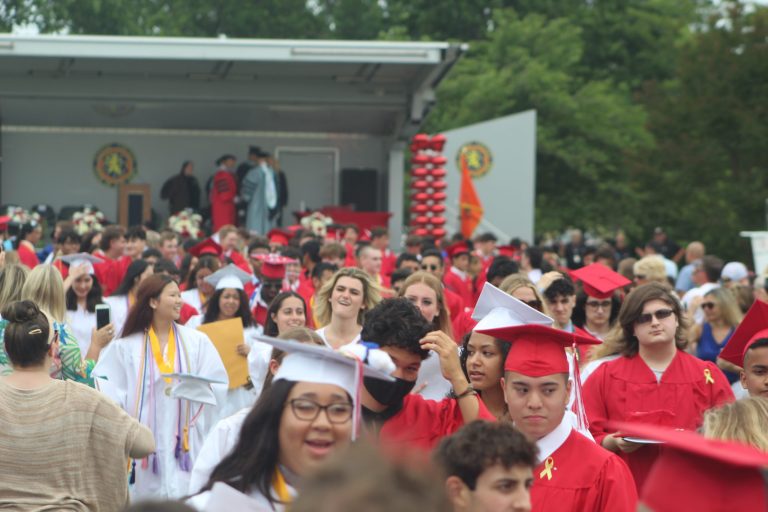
[531,430,637,512]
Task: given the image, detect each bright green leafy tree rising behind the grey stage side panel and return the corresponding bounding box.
[428,9,651,239]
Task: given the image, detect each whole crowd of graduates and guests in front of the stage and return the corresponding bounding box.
[0,214,768,512]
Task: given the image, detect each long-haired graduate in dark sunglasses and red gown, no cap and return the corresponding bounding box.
[584,283,734,489]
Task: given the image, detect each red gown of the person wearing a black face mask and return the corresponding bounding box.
[379,393,496,450]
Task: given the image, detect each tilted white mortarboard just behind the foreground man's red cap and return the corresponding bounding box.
[472,282,554,331]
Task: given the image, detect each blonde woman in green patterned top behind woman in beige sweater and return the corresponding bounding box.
[21,264,95,386]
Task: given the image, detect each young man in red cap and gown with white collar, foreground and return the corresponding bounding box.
[477,324,637,512]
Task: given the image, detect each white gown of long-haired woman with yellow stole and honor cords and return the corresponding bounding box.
[93,325,228,501]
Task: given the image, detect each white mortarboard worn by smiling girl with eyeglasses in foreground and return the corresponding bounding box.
[255,336,396,439]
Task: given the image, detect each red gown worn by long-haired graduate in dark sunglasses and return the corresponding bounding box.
[584,350,734,489]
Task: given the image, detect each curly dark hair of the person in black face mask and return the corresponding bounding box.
[360,298,433,359]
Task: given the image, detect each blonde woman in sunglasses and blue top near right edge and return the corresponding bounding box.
[690,288,744,384]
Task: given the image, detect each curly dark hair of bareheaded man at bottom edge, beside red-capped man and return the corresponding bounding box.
[434,421,538,490]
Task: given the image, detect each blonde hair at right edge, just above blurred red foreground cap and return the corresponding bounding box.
[703,396,768,452]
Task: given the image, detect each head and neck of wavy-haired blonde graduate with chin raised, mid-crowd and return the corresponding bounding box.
[315,267,381,348]
